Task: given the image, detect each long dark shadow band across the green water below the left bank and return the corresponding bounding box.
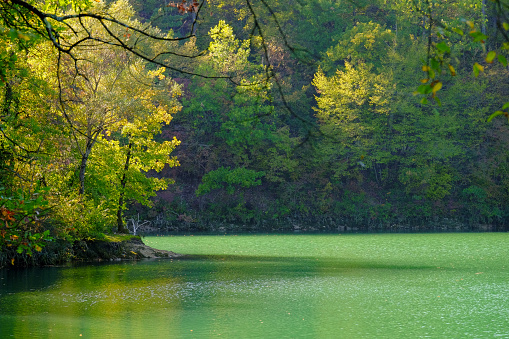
[0,254,434,297]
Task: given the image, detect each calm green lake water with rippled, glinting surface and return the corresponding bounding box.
[0,233,509,338]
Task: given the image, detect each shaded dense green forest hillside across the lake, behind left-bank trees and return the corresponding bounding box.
[135,1,509,234]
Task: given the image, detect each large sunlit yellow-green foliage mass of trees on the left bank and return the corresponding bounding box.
[0,1,180,239]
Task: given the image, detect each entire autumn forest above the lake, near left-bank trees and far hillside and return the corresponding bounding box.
[0,0,509,266]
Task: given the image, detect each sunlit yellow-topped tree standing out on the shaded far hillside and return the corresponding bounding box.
[313,61,392,182]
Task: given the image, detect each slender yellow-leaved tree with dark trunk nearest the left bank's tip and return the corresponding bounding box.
[86,69,181,233]
